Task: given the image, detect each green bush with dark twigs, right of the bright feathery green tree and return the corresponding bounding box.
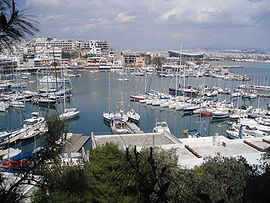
[126,148,178,202]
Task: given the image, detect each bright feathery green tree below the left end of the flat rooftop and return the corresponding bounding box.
[85,143,133,202]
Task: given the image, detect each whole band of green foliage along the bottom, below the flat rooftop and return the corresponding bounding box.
[29,143,269,203]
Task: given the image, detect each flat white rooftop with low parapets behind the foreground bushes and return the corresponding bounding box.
[91,132,270,168]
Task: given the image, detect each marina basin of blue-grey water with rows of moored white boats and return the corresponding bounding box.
[0,60,270,160]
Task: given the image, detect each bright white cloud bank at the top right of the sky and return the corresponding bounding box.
[159,0,270,25]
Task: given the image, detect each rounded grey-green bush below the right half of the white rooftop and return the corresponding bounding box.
[180,156,246,202]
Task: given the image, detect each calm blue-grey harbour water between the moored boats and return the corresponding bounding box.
[0,63,270,152]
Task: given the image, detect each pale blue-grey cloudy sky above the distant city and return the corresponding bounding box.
[22,0,270,51]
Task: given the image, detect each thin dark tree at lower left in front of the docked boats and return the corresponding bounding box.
[0,115,67,203]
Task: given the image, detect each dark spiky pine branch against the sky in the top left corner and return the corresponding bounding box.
[0,0,39,51]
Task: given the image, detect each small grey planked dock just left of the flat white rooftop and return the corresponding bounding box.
[64,133,90,153]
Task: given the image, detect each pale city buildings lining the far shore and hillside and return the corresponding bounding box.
[0,37,270,72]
